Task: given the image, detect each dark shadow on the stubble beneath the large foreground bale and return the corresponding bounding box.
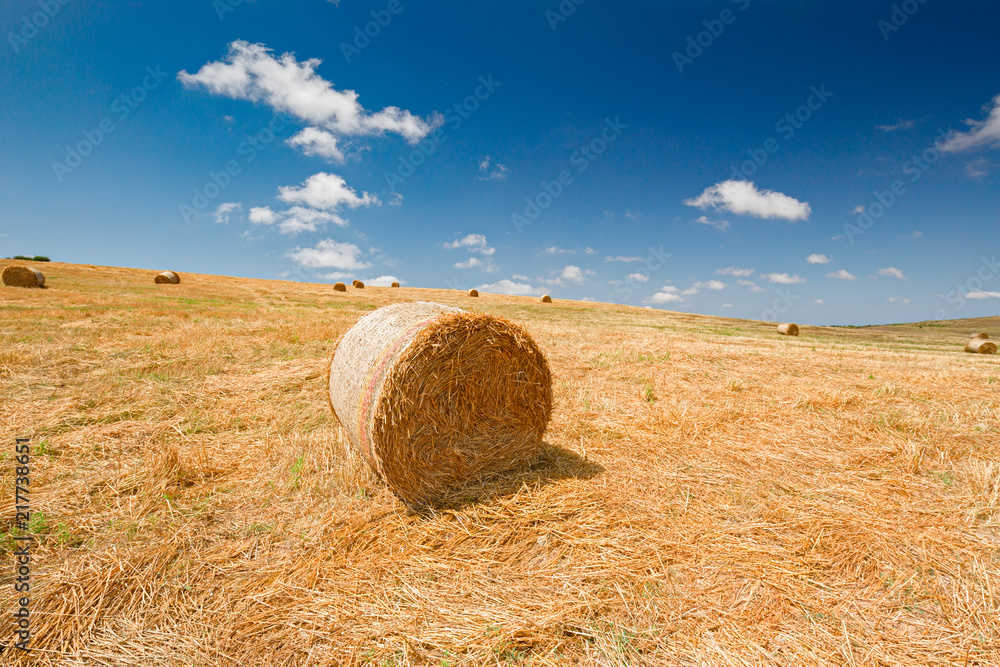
[407,442,605,517]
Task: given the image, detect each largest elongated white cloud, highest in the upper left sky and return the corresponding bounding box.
[177,40,443,149]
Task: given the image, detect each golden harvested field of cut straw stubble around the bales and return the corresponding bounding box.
[0,262,1000,667]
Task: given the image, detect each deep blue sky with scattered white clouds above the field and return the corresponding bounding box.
[0,0,1000,324]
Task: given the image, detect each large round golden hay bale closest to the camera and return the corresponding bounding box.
[329,302,552,505]
